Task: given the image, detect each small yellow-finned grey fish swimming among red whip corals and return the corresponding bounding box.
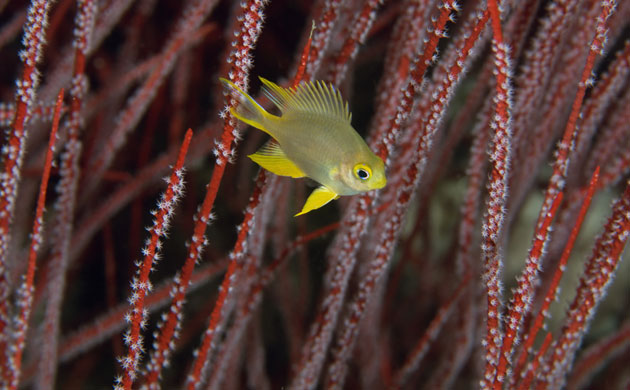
[219,77,387,217]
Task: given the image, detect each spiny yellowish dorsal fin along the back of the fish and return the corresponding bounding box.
[260,77,352,123]
